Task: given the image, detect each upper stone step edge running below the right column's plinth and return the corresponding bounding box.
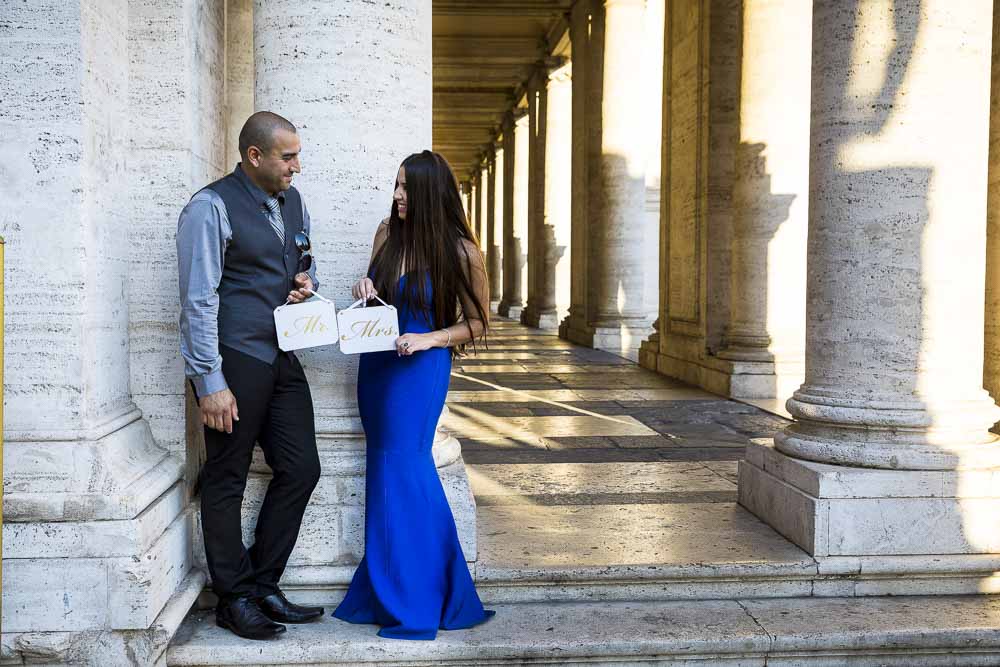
[240,556,1000,606]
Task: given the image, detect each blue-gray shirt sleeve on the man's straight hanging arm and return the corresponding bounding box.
[177,190,233,397]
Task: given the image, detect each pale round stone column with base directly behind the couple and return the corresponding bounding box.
[256,0,476,595]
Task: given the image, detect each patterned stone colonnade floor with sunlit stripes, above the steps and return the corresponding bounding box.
[444,319,812,588]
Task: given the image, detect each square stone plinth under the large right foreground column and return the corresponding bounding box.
[739,441,1000,556]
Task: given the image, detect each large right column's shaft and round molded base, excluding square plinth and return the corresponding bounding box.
[775,0,1000,469]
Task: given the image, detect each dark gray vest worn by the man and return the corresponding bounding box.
[200,170,302,364]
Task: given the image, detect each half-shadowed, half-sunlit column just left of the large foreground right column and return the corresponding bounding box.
[718,0,812,398]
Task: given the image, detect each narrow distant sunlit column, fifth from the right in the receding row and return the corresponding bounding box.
[498,114,530,320]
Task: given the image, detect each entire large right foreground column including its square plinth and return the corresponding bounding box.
[740,0,1000,562]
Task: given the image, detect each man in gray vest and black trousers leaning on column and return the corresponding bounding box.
[177,111,323,639]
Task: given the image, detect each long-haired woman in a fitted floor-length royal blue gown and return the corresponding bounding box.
[334,151,493,639]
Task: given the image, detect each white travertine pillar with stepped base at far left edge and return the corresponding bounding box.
[0,0,199,665]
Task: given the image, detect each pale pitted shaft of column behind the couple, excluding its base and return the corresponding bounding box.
[254,0,431,433]
